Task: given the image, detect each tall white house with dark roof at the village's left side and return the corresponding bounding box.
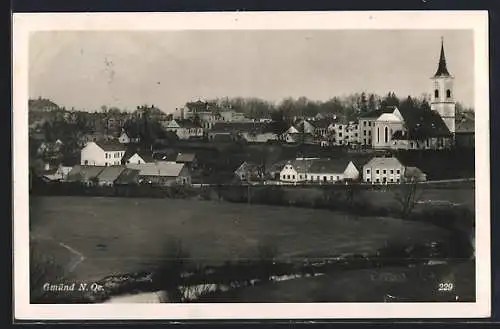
[80,142,125,166]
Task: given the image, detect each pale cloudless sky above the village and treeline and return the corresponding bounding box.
[29,30,474,113]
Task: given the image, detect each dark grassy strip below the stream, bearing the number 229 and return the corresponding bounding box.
[204,261,476,303]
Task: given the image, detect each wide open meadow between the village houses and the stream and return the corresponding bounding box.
[30,197,452,280]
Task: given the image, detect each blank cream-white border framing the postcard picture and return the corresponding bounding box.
[13,11,491,320]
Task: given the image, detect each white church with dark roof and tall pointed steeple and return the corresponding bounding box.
[371,40,455,150]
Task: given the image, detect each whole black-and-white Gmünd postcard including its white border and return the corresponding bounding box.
[13,12,490,319]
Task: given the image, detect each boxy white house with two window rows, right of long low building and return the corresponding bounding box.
[363,157,405,184]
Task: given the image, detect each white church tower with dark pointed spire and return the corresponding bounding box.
[431,38,455,133]
